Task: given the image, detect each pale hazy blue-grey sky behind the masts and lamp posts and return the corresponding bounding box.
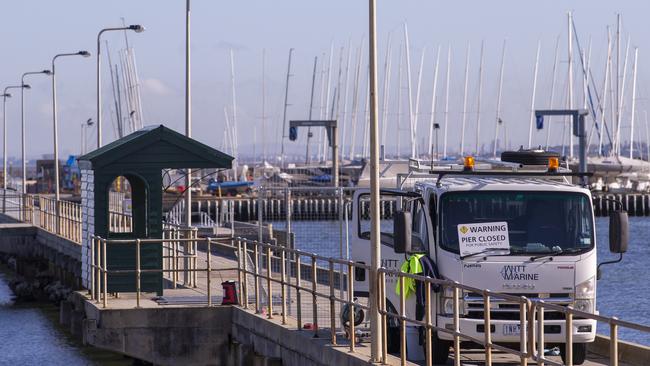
[0,0,650,159]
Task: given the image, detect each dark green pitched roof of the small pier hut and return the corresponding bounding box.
[78,125,234,169]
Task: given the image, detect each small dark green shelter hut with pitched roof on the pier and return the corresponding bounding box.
[78,125,233,294]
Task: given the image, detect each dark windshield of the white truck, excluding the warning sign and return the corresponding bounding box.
[439,191,594,255]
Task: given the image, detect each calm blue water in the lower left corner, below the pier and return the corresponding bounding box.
[0,273,129,366]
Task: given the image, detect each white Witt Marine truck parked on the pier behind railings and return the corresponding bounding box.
[350,152,627,364]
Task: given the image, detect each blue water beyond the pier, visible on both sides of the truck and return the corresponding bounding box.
[282,217,650,345]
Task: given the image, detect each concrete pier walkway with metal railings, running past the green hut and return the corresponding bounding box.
[0,190,650,365]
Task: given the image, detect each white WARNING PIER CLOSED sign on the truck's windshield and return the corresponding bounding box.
[458,221,510,256]
